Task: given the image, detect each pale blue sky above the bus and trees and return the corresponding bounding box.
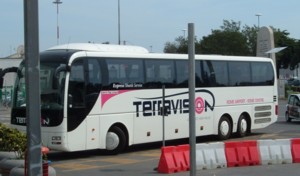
[0,0,300,58]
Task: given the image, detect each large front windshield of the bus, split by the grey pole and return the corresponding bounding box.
[15,62,65,110]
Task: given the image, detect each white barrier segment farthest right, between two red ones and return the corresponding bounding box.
[258,139,293,165]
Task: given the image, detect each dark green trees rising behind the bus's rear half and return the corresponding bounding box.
[164,20,300,70]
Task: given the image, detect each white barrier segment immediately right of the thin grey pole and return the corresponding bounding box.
[196,142,227,170]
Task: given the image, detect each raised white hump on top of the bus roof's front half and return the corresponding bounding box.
[47,43,149,54]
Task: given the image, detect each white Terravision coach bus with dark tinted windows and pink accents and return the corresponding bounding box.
[2,43,278,153]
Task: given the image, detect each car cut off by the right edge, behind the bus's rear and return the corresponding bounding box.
[285,94,300,122]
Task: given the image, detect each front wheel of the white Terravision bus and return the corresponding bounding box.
[106,126,127,155]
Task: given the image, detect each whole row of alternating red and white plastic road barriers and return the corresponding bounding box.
[158,138,300,173]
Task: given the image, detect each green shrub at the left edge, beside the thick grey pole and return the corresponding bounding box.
[0,123,27,158]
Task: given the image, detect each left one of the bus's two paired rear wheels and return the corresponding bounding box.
[218,116,232,140]
